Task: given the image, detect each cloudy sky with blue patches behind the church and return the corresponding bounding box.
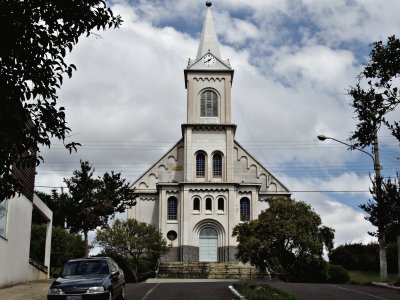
[36,0,400,245]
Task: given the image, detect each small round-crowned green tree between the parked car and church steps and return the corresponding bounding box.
[95,219,168,282]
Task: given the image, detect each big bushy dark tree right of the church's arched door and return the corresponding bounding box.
[232,199,334,281]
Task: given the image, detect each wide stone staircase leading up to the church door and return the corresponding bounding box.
[157,262,266,279]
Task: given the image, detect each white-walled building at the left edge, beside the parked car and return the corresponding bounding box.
[0,183,53,288]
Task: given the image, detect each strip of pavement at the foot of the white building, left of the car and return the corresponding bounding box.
[0,280,53,300]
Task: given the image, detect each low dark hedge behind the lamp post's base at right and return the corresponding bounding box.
[329,243,397,272]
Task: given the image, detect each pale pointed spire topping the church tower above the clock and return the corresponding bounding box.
[196,1,221,59]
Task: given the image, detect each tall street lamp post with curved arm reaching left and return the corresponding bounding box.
[318,131,388,282]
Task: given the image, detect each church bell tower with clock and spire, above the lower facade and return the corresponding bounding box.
[182,1,236,182]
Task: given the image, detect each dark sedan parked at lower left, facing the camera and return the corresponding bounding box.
[47,257,125,300]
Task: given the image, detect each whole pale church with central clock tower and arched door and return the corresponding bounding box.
[127,1,291,262]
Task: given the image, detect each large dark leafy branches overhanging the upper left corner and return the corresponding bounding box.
[0,0,122,199]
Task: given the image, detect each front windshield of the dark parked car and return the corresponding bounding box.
[62,260,109,276]
